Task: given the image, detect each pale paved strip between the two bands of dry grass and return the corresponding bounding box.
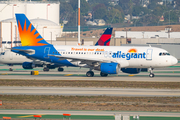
[0,86,180,97]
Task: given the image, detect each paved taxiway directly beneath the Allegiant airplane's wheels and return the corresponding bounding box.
[0,63,180,82]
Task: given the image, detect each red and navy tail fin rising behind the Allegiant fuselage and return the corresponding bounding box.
[95,27,113,46]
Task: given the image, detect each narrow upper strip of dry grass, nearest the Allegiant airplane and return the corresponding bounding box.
[0,80,180,89]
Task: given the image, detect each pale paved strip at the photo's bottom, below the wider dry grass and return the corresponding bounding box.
[0,110,180,117]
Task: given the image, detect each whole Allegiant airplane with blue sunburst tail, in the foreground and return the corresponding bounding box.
[11,14,178,78]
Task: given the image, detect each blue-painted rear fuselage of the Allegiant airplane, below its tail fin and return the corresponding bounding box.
[12,45,75,66]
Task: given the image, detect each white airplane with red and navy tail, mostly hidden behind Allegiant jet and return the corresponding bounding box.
[0,27,113,72]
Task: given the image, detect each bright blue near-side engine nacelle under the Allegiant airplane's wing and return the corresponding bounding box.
[100,63,120,74]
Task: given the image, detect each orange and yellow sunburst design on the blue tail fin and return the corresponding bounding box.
[18,19,47,46]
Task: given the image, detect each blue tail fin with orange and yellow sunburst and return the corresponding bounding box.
[16,14,49,46]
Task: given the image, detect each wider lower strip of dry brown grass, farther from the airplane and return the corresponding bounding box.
[0,95,180,112]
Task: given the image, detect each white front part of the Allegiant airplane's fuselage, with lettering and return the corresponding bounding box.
[54,46,177,68]
